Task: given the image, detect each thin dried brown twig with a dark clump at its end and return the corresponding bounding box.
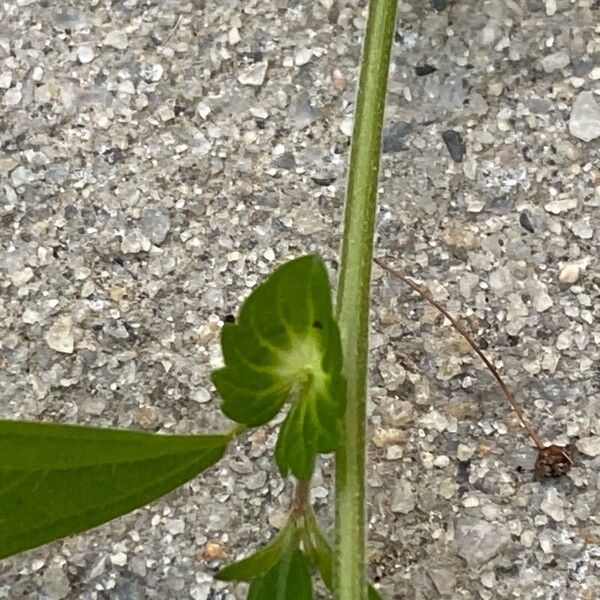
[373,258,573,476]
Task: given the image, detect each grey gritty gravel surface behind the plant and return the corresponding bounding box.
[0,0,600,600]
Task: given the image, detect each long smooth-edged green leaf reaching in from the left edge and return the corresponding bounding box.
[0,421,229,558]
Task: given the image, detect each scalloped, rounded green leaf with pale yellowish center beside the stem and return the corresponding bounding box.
[212,256,346,479]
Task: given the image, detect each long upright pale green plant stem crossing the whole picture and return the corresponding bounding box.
[334,0,397,600]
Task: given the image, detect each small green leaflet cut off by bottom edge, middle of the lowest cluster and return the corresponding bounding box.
[248,548,312,600]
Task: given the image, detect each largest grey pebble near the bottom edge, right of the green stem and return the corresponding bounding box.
[455,516,510,567]
